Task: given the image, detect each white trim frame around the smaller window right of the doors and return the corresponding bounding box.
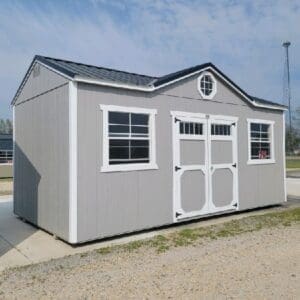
[247,119,276,165]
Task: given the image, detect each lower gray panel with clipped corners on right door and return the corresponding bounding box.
[212,168,233,208]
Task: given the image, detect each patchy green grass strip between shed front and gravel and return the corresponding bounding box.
[96,208,300,254]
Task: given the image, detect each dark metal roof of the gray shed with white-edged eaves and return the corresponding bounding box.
[12,55,286,109]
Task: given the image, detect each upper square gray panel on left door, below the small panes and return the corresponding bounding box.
[180,140,206,165]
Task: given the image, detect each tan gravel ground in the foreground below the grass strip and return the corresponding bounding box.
[0,224,300,299]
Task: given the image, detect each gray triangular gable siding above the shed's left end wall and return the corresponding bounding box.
[16,63,68,104]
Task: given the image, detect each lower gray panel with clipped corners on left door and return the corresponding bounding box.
[181,170,206,213]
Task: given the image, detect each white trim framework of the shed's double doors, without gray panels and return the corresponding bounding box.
[171,111,239,222]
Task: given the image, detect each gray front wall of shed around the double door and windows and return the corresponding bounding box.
[77,76,285,242]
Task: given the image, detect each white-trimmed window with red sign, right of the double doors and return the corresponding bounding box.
[248,120,274,163]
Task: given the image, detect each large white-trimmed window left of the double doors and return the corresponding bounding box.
[101,105,156,171]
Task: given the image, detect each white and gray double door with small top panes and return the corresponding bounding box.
[172,112,238,221]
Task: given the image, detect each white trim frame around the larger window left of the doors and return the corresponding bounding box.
[100,104,158,172]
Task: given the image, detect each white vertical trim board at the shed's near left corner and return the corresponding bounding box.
[69,81,77,244]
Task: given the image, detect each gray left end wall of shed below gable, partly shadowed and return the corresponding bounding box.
[14,83,69,239]
